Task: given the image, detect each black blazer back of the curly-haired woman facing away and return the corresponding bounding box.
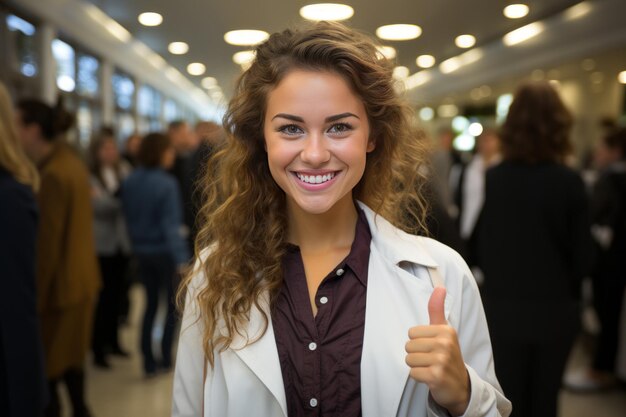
[477,161,592,337]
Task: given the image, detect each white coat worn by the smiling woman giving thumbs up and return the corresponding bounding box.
[172,203,511,417]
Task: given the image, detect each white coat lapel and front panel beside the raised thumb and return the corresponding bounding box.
[360,203,444,417]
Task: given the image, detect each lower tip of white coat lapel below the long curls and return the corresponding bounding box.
[231,297,287,417]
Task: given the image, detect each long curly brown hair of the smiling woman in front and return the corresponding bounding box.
[178,22,426,365]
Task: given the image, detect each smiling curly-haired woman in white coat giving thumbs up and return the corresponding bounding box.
[173,23,510,417]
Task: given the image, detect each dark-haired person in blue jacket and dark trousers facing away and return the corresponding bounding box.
[121,133,189,377]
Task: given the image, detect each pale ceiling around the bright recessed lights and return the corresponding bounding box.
[9,0,626,110]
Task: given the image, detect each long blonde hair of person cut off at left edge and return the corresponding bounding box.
[0,83,39,191]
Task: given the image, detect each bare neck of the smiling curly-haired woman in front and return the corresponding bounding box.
[287,195,358,253]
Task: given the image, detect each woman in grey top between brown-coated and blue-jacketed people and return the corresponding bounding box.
[89,131,132,368]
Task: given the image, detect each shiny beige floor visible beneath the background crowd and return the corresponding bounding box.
[66,286,626,417]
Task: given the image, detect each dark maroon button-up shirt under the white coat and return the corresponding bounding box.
[272,209,372,417]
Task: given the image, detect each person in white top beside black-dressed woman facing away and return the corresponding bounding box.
[459,128,502,270]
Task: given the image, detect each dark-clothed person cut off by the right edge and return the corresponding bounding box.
[565,128,626,391]
